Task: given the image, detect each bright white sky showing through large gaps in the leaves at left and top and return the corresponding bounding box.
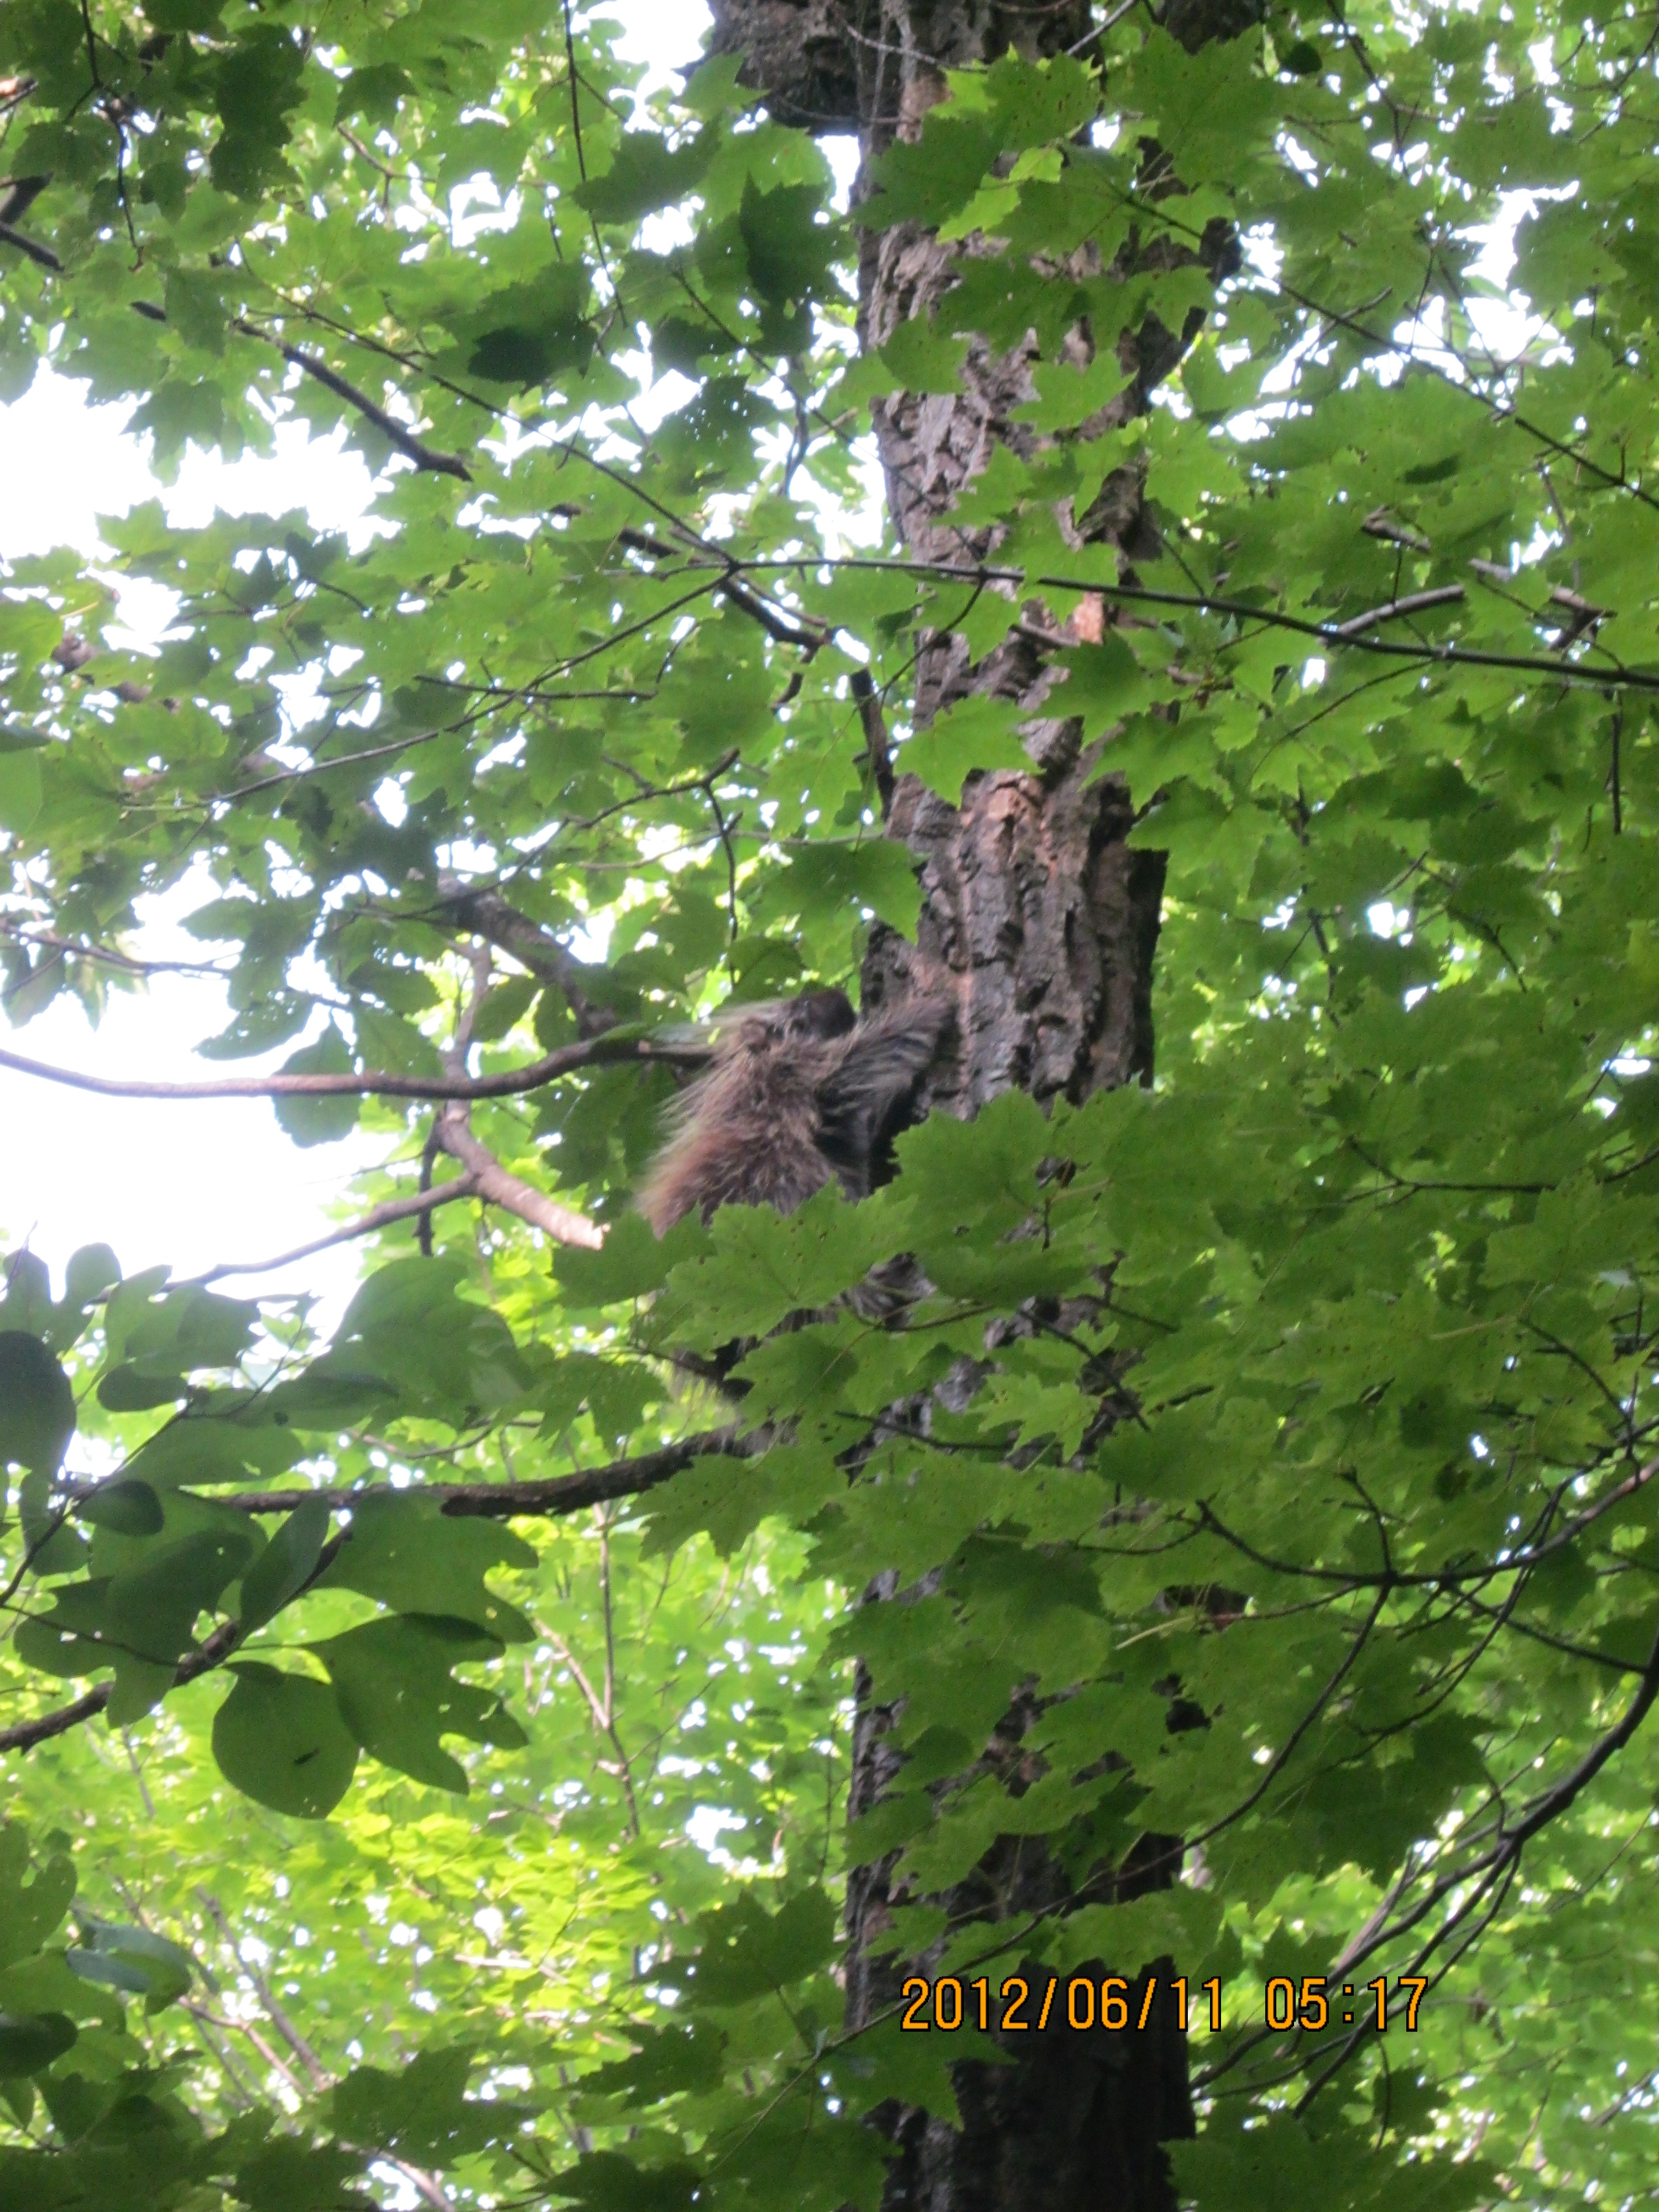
[0,0,708,1310]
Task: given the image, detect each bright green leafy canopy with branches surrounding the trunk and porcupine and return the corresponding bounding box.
[0,0,1659,2212]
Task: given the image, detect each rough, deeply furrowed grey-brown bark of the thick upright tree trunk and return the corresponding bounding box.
[712,0,1261,2212]
